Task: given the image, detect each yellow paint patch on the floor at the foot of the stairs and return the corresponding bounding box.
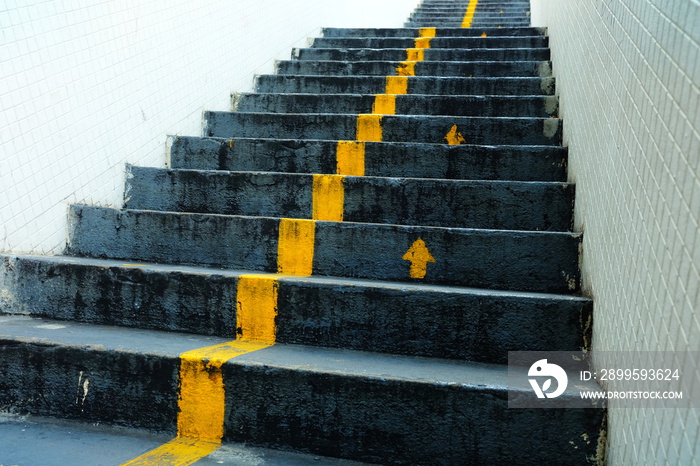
[123,438,221,466]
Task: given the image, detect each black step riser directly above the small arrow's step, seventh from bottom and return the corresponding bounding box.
[233,94,559,117]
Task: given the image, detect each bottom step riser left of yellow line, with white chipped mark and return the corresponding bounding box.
[0,338,178,432]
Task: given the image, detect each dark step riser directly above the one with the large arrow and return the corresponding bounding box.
[124,165,574,231]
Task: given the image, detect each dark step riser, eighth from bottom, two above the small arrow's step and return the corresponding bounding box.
[255,74,555,95]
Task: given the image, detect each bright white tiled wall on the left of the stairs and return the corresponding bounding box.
[0,0,418,253]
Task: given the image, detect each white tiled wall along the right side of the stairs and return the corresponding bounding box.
[532,0,700,466]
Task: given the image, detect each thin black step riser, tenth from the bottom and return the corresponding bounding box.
[292,48,550,62]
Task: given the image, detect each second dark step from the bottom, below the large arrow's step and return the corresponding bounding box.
[0,256,592,364]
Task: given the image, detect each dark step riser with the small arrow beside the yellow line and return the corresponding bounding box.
[203,111,562,145]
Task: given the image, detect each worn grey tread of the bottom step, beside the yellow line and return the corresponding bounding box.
[0,315,598,399]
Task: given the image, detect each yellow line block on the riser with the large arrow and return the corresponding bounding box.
[277,218,316,277]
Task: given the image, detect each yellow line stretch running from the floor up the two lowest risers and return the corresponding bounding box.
[124,274,279,466]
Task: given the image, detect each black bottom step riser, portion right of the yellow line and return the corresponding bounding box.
[225,365,602,466]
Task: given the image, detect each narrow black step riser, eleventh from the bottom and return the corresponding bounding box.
[310,36,549,49]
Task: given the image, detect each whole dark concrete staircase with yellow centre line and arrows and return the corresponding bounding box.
[0,0,604,465]
